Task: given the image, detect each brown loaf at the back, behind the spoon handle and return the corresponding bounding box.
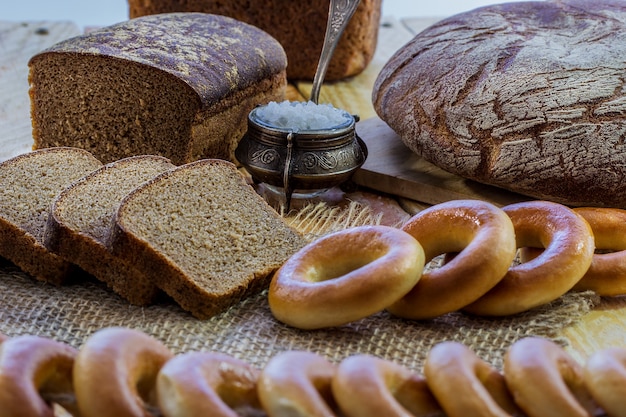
[128,0,382,81]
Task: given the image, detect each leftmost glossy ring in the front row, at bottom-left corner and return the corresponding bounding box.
[0,336,79,417]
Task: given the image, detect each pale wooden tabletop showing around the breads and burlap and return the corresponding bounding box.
[0,18,626,361]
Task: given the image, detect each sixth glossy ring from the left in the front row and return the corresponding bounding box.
[424,342,520,417]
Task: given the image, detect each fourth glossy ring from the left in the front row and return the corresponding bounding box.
[257,351,335,417]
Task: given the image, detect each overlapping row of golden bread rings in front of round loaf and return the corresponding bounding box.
[268,200,626,329]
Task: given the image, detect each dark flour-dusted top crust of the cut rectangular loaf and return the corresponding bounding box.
[30,13,287,109]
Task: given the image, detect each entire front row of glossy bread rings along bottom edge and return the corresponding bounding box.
[0,327,626,417]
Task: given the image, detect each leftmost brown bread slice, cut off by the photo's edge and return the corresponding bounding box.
[0,148,102,285]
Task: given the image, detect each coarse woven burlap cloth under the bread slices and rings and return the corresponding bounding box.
[0,200,596,371]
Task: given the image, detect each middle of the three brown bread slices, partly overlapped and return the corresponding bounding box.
[44,155,175,305]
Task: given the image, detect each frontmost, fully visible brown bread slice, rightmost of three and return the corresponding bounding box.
[112,159,305,319]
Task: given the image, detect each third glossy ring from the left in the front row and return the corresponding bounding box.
[157,352,260,417]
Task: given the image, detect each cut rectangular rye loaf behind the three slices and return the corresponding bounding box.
[29,13,287,165]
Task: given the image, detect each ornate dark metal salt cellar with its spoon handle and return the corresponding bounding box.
[235,0,367,210]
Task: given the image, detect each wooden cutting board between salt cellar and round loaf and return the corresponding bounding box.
[353,117,529,206]
